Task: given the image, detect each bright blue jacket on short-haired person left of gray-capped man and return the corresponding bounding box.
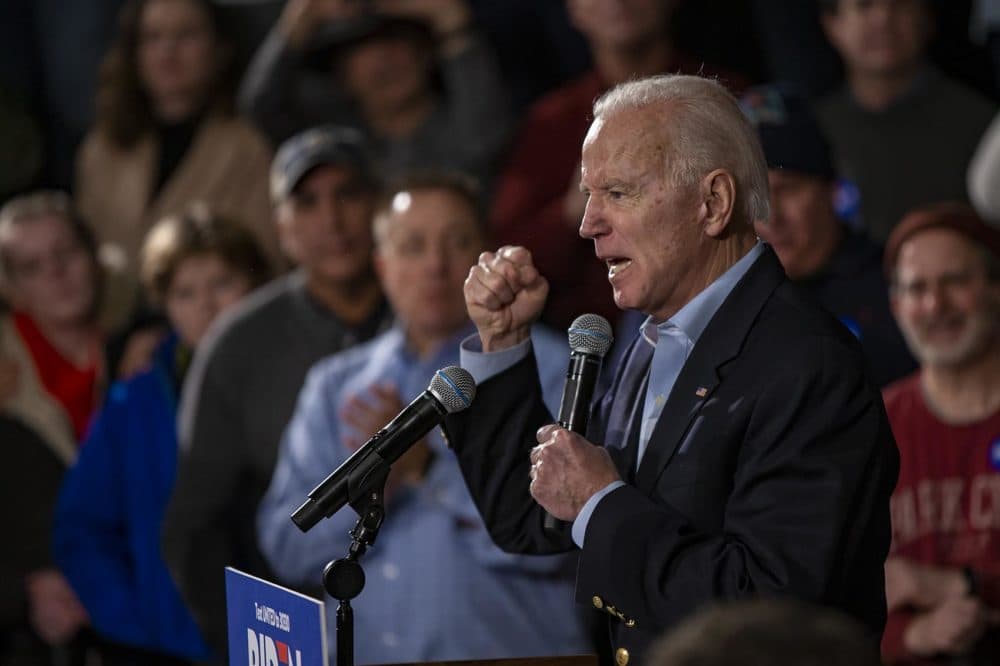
[53,337,211,659]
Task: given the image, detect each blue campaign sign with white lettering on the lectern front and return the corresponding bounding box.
[226,567,327,666]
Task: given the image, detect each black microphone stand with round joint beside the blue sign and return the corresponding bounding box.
[323,465,389,666]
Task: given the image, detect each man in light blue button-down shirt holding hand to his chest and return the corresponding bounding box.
[258,176,592,664]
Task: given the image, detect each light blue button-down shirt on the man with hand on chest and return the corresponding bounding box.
[258,326,590,665]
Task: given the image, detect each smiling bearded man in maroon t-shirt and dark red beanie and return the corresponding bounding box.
[882,204,1000,666]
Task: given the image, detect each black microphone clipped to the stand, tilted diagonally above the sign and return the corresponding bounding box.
[292,365,476,532]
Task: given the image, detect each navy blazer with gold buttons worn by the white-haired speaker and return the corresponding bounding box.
[445,248,899,663]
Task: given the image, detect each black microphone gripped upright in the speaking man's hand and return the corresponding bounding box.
[545,314,615,530]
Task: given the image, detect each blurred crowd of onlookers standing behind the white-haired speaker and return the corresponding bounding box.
[0,0,1000,666]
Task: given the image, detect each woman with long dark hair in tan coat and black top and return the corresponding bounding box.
[76,0,279,330]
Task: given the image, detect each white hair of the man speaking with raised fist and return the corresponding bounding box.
[594,74,771,223]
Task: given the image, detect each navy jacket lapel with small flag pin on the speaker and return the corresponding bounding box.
[636,246,785,492]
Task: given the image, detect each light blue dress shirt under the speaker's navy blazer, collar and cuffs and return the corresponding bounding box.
[461,242,764,548]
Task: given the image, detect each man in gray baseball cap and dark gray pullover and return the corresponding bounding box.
[163,126,390,657]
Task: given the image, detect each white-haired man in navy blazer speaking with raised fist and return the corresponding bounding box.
[445,76,898,666]
